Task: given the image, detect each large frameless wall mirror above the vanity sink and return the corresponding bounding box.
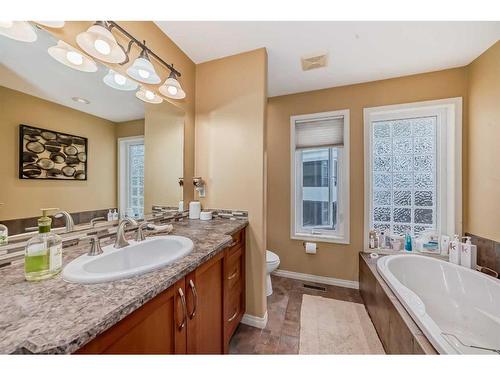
[0,27,184,235]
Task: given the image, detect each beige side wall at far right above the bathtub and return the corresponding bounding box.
[464,42,500,241]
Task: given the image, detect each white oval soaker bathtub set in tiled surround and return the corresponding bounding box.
[377,254,500,354]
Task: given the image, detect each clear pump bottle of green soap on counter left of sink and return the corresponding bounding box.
[24,208,62,281]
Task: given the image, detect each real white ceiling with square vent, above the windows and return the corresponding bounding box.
[156,21,500,96]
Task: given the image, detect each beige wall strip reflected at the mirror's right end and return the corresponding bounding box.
[144,103,185,213]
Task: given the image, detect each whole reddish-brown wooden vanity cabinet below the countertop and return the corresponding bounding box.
[76,229,245,354]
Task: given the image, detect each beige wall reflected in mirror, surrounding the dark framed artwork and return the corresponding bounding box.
[0,87,116,220]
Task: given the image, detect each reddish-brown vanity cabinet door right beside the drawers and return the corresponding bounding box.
[186,253,224,354]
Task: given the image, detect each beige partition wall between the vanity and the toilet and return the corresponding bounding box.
[196,49,267,317]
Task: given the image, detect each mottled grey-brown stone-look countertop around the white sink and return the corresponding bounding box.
[0,218,248,354]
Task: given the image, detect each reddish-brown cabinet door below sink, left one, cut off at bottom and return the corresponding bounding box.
[76,279,187,354]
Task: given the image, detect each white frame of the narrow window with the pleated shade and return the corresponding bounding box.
[290,109,350,244]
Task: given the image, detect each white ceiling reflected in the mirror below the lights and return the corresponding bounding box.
[0,28,144,122]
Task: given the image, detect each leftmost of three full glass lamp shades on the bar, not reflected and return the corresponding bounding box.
[76,21,127,64]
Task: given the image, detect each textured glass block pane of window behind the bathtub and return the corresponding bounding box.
[370,116,438,235]
